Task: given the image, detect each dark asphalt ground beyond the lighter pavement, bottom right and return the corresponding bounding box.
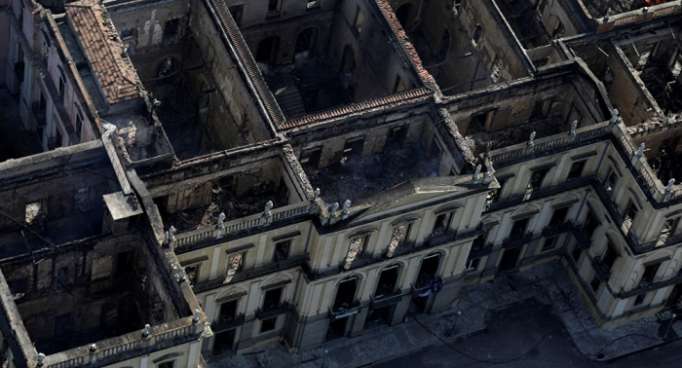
[371,300,682,368]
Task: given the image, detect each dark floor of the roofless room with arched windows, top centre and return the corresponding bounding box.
[261,58,352,118]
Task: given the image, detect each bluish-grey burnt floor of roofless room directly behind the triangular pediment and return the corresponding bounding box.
[307,145,440,204]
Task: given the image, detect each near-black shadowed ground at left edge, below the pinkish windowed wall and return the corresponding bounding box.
[0,88,42,162]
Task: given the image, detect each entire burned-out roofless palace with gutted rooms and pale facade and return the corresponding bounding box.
[0,0,682,368]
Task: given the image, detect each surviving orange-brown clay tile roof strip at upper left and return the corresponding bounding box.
[65,0,140,105]
